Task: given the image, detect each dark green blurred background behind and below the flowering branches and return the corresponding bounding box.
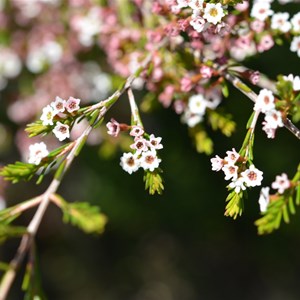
[0,1,300,300]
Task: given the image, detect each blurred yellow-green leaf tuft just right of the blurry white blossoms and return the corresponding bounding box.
[208,109,236,137]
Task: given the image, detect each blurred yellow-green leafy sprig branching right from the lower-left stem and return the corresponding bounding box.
[55,195,107,234]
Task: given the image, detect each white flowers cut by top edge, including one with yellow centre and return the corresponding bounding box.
[171,0,225,32]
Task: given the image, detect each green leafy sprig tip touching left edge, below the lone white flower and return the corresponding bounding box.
[0,161,40,183]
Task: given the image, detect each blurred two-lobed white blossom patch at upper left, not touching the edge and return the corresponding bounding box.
[26,41,63,73]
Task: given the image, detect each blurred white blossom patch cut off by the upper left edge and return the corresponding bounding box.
[0,47,22,91]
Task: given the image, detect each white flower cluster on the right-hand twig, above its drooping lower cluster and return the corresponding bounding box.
[254,89,283,139]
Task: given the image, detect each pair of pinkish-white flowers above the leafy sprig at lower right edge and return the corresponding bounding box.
[258,173,291,212]
